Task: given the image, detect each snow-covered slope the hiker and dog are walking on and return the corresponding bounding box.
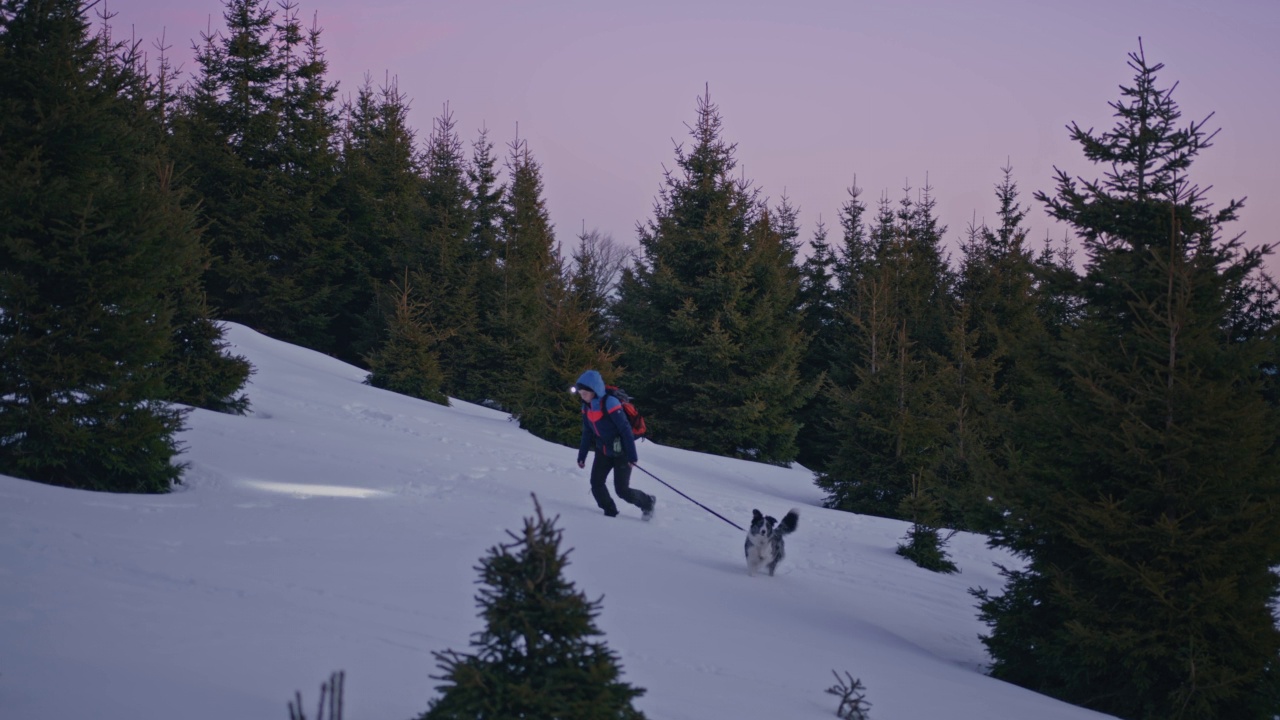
[0,325,1103,720]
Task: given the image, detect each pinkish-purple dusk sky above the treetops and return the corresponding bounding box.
[109,0,1280,274]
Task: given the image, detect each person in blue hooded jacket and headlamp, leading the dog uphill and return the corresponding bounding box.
[573,370,658,520]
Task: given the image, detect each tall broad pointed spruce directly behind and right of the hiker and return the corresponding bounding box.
[617,92,808,462]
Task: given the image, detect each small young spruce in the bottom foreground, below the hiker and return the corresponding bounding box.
[420,497,645,720]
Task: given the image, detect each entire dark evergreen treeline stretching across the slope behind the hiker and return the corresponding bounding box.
[0,0,1280,719]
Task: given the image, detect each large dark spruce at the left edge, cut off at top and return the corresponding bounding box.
[0,0,232,492]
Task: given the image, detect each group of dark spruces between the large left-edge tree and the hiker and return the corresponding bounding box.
[165,0,613,442]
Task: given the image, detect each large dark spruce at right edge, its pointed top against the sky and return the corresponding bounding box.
[975,49,1280,720]
